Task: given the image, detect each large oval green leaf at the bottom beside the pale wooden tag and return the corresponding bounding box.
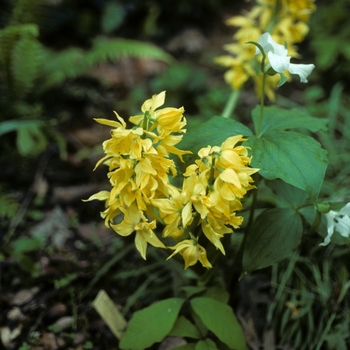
[119,298,185,350]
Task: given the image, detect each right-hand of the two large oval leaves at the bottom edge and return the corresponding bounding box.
[190,297,247,350]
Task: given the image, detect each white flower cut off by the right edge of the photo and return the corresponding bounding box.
[320,202,350,246]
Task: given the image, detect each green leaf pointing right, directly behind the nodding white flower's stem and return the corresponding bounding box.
[252,106,328,136]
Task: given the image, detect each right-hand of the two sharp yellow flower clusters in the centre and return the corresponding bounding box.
[152,135,258,268]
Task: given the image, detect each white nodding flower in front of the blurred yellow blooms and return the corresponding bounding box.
[256,33,315,83]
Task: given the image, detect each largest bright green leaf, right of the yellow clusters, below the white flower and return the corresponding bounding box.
[245,131,327,201]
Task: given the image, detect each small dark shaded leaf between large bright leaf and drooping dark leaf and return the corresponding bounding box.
[266,179,308,210]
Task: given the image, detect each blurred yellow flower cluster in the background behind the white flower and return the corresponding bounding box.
[216,0,315,100]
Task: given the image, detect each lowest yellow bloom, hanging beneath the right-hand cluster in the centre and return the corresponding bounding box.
[167,239,212,269]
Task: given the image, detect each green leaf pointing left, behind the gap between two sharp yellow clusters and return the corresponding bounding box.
[179,117,252,155]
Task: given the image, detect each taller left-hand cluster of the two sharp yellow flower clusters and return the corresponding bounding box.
[88,91,191,259]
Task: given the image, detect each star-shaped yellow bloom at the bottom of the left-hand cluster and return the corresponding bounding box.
[111,204,165,260]
